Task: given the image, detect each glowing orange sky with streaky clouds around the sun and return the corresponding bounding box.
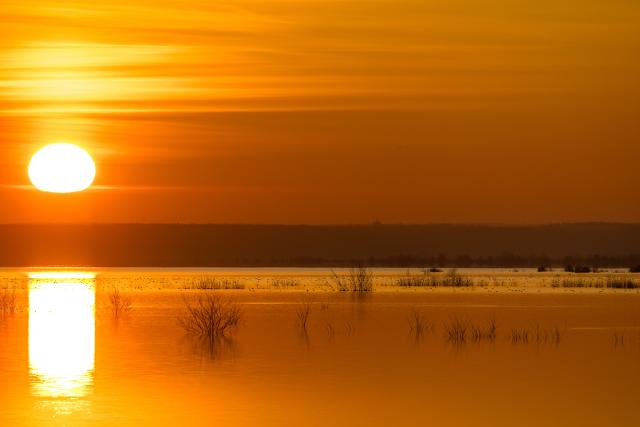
[0,0,640,223]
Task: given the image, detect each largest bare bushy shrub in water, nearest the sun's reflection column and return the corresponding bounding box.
[178,295,242,340]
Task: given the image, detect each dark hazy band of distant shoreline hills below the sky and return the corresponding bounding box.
[0,223,640,268]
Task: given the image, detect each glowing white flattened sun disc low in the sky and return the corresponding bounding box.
[29,143,96,193]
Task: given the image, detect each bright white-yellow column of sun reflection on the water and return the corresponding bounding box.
[29,272,95,399]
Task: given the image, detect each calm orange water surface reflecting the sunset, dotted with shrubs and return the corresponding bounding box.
[0,269,640,426]
